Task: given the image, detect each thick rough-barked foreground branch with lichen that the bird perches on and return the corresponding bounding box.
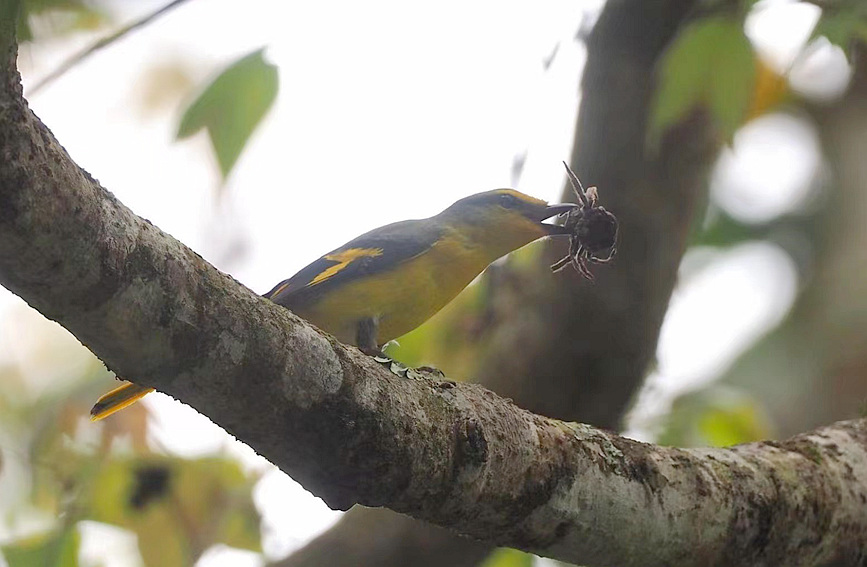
[0,13,867,565]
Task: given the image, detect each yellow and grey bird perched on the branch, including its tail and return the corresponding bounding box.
[90,189,578,421]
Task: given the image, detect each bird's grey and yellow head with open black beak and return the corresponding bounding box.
[440,189,577,257]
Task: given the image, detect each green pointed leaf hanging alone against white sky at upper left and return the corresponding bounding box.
[177,48,278,178]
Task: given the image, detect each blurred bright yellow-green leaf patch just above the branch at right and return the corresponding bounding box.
[658,384,773,447]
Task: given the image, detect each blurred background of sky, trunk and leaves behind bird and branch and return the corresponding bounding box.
[0,0,867,567]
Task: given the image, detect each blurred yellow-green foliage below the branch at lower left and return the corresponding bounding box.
[0,320,261,567]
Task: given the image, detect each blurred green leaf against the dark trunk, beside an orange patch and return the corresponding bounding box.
[647,16,756,148]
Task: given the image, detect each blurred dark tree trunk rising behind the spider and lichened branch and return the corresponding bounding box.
[279,0,718,567]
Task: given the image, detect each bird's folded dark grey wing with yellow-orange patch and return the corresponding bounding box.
[264,219,442,309]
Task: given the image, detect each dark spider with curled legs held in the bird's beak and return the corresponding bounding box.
[551,162,617,281]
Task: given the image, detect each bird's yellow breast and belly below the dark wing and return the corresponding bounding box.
[293,232,496,344]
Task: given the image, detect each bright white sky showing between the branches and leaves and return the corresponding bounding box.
[0,0,844,567]
